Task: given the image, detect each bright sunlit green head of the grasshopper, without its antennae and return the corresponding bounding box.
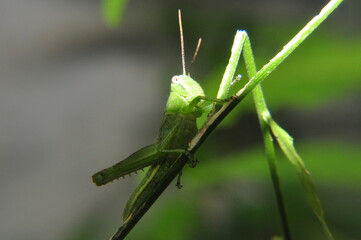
[165,75,204,117]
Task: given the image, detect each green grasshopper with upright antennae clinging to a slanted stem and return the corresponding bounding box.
[93,11,227,240]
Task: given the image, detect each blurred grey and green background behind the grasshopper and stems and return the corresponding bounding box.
[0,0,361,240]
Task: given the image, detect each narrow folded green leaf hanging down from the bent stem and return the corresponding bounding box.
[264,116,334,239]
